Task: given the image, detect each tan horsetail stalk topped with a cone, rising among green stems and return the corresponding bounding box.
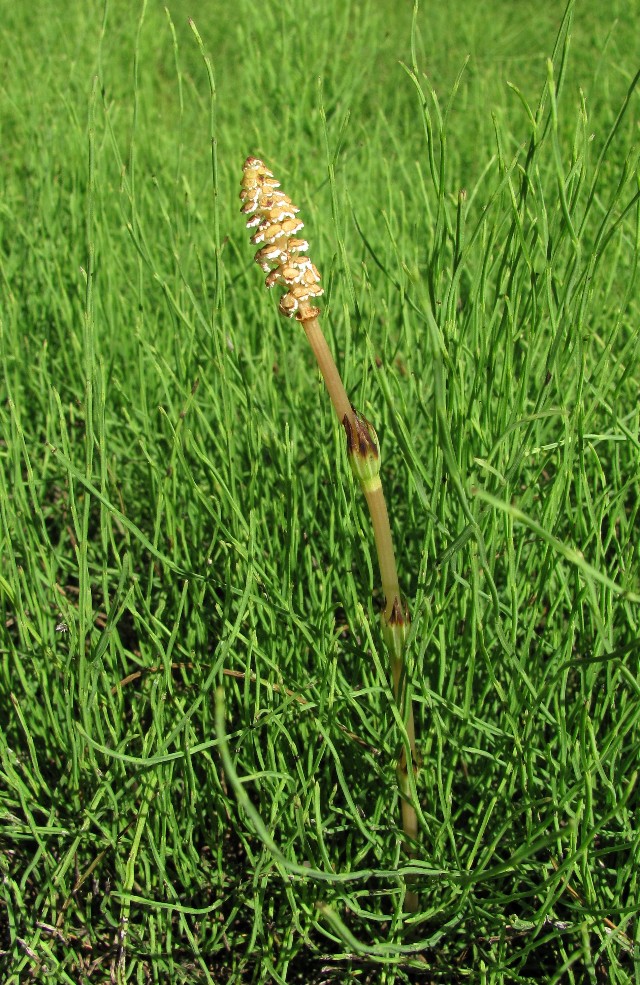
[240,157,418,911]
